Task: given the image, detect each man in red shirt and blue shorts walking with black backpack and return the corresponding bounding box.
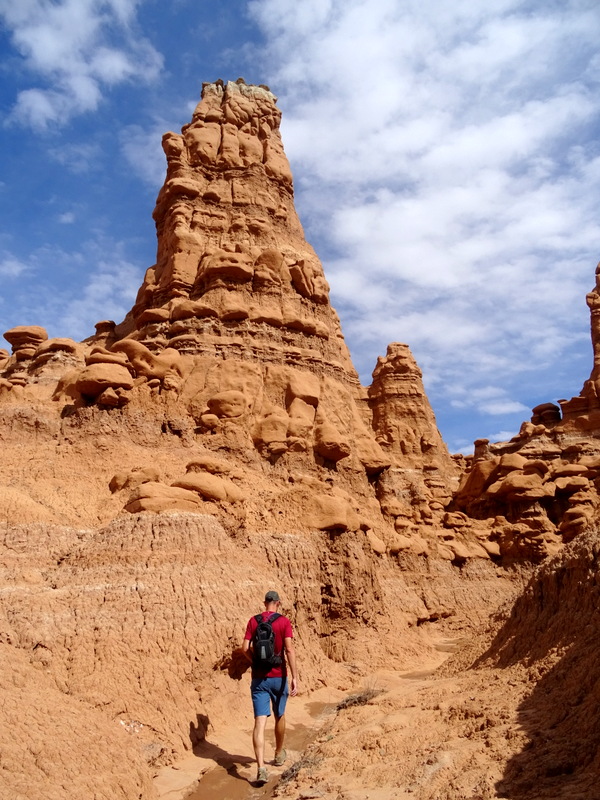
[243,591,298,786]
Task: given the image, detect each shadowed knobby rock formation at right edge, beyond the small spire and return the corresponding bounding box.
[453,265,600,560]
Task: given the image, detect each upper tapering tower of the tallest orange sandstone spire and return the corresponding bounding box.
[125,81,357,378]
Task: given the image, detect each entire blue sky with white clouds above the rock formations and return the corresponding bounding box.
[0,0,600,451]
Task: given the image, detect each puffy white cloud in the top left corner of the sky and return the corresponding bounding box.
[0,0,162,129]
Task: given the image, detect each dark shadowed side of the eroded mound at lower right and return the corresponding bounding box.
[480,530,600,800]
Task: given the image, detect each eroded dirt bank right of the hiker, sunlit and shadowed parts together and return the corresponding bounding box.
[277,531,600,800]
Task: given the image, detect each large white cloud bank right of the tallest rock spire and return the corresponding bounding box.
[250,0,600,450]
